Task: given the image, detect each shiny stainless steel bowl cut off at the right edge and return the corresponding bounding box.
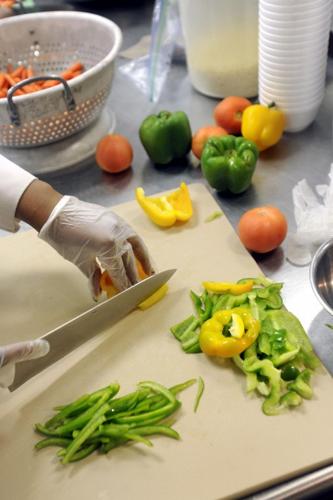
[310,239,333,315]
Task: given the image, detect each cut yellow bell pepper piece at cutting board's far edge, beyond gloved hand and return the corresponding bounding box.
[135,182,193,227]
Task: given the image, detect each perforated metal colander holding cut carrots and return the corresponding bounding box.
[0,12,122,148]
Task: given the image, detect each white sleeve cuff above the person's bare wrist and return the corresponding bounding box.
[0,155,36,232]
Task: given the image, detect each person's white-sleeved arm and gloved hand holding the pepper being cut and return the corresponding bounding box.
[0,156,153,296]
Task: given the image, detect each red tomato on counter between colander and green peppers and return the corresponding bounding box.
[96,134,133,174]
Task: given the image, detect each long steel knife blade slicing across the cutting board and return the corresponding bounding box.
[9,269,176,391]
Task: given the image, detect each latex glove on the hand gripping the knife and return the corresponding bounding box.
[0,339,50,388]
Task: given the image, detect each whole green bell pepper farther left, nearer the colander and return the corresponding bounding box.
[139,111,192,165]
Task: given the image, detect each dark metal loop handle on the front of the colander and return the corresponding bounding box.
[7,75,76,127]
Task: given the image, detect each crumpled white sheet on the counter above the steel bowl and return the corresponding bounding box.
[286,163,333,266]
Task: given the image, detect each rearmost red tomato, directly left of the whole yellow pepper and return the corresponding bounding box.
[214,96,252,134]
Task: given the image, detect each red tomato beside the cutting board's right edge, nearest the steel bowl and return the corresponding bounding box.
[238,205,288,253]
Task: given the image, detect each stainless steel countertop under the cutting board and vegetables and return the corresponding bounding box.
[0,1,333,498]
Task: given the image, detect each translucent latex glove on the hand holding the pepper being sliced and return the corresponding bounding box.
[39,196,153,297]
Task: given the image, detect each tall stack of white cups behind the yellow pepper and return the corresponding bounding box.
[259,0,333,132]
